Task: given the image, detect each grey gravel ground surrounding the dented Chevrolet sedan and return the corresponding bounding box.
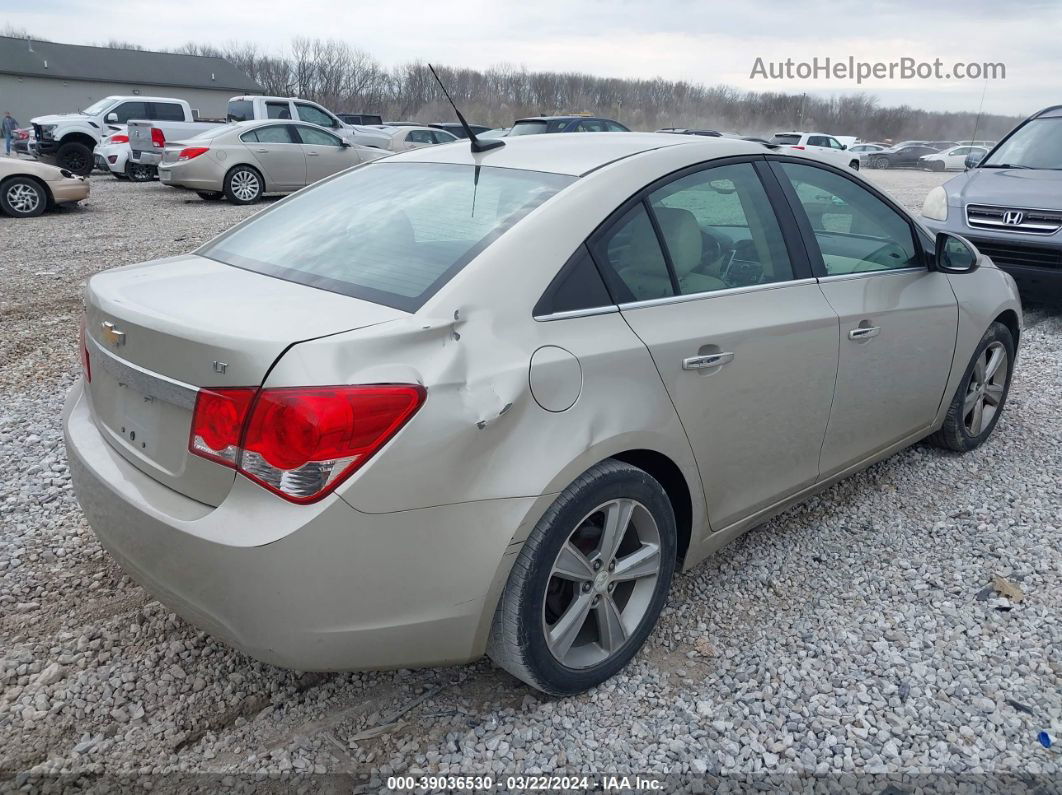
[0,164,1062,790]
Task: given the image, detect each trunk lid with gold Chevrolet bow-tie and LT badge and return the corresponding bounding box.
[85,255,406,505]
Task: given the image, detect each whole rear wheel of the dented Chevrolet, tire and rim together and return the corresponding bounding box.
[487,459,678,695]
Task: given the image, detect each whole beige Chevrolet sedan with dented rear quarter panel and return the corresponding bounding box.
[65,134,1021,694]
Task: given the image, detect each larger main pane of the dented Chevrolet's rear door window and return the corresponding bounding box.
[649,162,793,295]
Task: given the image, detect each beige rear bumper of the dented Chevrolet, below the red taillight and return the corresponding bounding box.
[63,382,526,670]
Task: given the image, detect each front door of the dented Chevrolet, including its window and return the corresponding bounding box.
[773,159,958,478]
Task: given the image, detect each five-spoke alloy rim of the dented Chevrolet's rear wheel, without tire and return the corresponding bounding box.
[542,499,662,669]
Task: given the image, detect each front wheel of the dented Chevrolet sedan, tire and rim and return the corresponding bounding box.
[929,323,1015,453]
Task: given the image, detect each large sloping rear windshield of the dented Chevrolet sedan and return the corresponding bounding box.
[199,162,576,312]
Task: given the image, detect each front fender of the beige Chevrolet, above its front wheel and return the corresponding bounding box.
[937,264,1024,426]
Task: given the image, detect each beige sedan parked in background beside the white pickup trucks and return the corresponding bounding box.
[158,119,387,204]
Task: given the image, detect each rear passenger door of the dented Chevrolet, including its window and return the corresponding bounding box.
[592,158,837,531]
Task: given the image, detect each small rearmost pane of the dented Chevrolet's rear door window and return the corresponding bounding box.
[595,202,675,301]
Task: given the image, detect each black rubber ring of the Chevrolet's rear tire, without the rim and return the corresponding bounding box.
[509,467,678,694]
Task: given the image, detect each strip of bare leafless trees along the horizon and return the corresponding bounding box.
[4,29,1021,141]
